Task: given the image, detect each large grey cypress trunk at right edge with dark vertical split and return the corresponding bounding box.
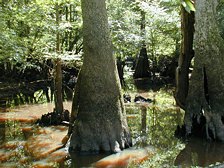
[185,0,224,141]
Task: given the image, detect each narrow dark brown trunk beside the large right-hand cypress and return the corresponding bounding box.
[174,6,194,109]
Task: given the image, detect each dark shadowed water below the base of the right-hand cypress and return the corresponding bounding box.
[175,138,224,167]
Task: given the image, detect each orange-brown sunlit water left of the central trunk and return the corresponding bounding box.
[0,102,71,168]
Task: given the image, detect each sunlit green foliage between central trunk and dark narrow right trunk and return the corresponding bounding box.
[107,0,180,67]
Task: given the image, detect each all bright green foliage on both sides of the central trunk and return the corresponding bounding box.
[0,0,180,75]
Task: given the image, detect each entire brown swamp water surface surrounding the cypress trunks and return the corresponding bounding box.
[0,99,224,168]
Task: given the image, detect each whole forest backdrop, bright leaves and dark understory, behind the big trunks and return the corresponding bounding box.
[0,0,224,167]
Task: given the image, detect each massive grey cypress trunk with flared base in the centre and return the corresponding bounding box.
[70,0,131,152]
